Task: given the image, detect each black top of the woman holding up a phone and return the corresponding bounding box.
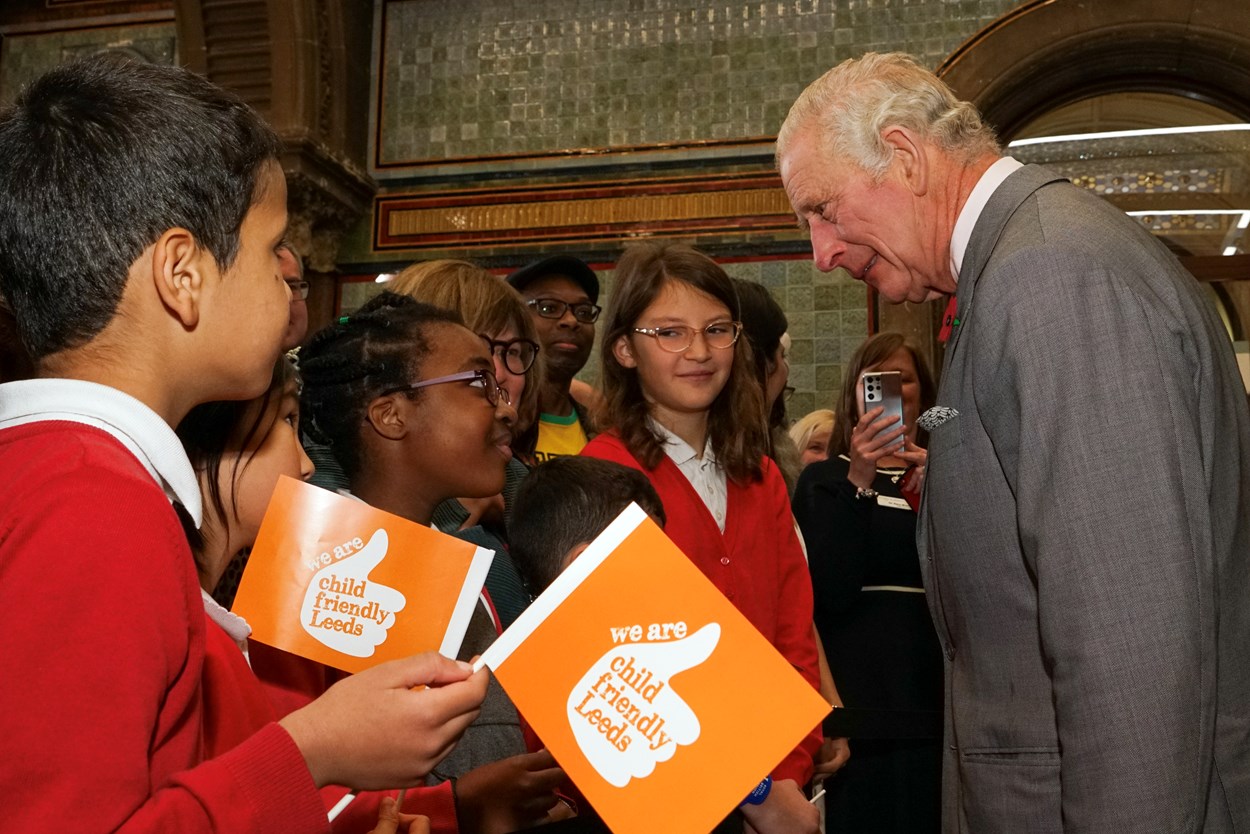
[794,458,943,710]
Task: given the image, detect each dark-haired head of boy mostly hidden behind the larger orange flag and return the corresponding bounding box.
[508,456,665,595]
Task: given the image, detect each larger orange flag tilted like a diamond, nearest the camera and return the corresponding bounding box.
[480,504,830,834]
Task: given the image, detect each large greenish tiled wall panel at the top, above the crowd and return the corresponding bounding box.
[376,0,1021,171]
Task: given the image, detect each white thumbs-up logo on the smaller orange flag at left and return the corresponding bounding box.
[300,530,408,658]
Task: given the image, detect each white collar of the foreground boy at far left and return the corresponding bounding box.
[0,379,203,526]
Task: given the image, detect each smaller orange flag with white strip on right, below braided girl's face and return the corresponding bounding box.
[234,476,495,673]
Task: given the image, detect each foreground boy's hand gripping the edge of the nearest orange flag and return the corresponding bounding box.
[279,651,489,790]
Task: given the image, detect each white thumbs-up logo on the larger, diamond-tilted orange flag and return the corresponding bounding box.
[569,623,720,788]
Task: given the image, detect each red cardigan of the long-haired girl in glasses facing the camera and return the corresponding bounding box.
[581,431,821,785]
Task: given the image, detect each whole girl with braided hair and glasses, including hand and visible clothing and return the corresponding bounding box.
[253,293,572,833]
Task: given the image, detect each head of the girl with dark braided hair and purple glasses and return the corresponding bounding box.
[300,293,516,512]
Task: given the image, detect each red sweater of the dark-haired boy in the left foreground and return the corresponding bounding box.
[0,421,328,834]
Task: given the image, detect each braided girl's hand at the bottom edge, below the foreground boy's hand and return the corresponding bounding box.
[456,750,564,834]
